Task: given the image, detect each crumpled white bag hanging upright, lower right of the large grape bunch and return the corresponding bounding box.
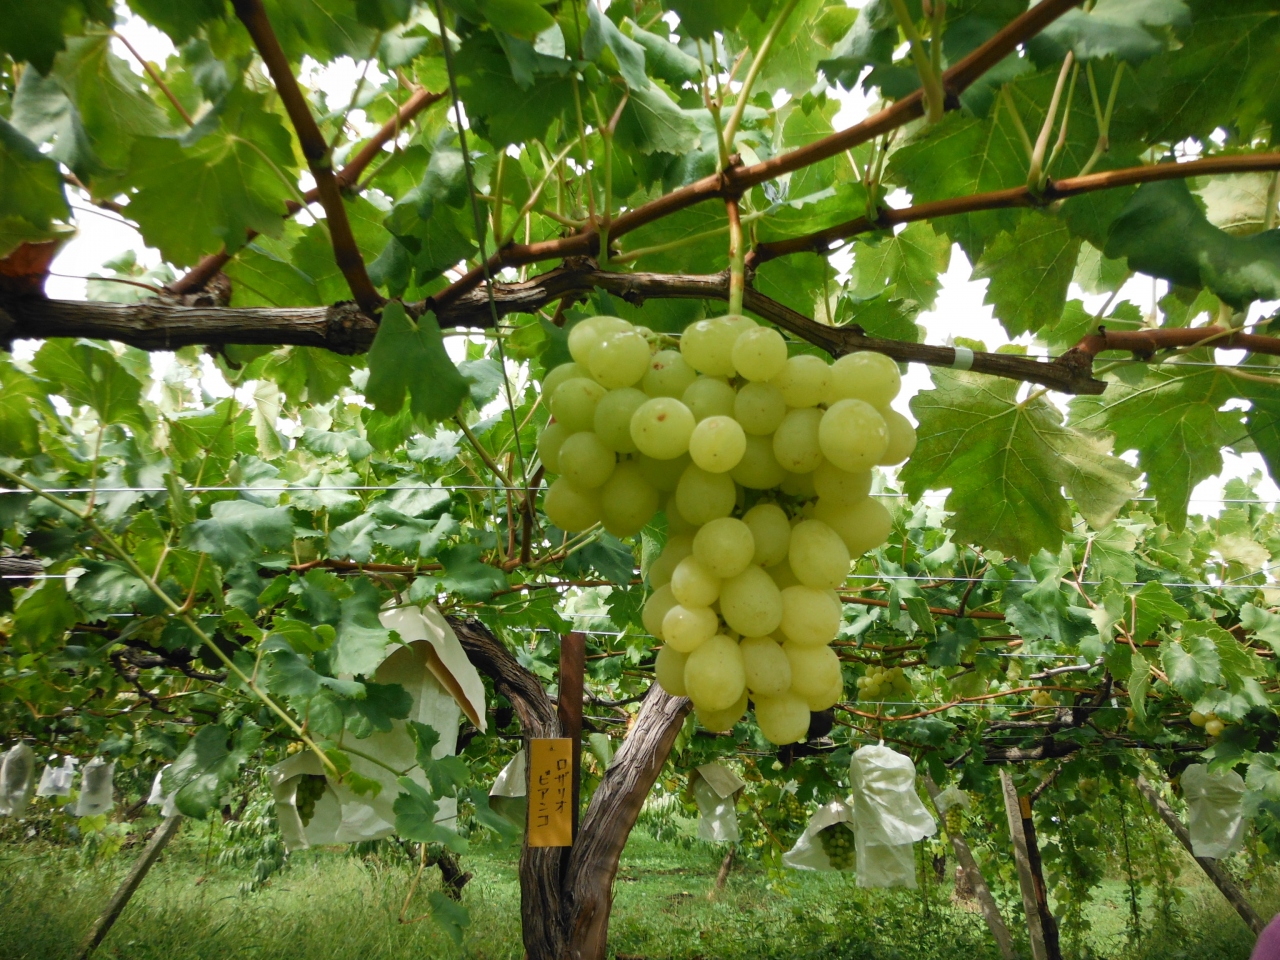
[849,745,938,890]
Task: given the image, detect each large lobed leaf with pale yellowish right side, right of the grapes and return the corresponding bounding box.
[900,370,1138,558]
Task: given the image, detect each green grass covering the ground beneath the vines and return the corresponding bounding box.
[0,827,1272,960]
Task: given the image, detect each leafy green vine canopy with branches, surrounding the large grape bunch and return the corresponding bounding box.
[0,0,1280,957]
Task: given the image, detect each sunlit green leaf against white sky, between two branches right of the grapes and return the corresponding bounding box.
[973,210,1080,337]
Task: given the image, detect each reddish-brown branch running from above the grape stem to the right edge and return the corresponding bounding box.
[748,154,1280,266]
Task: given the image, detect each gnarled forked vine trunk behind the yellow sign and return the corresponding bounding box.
[452,620,690,960]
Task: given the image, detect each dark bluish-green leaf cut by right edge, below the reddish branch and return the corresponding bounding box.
[1105,180,1280,306]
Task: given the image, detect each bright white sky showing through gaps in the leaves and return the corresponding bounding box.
[32,0,1280,515]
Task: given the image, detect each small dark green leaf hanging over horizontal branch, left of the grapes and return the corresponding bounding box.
[365,301,470,421]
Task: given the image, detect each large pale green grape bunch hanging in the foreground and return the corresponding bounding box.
[538,316,915,745]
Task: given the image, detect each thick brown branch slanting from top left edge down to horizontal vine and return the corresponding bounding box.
[232,0,383,316]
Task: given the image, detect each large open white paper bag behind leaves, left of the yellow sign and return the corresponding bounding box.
[268,605,488,850]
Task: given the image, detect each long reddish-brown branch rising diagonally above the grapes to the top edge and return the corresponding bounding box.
[433,0,1079,307]
